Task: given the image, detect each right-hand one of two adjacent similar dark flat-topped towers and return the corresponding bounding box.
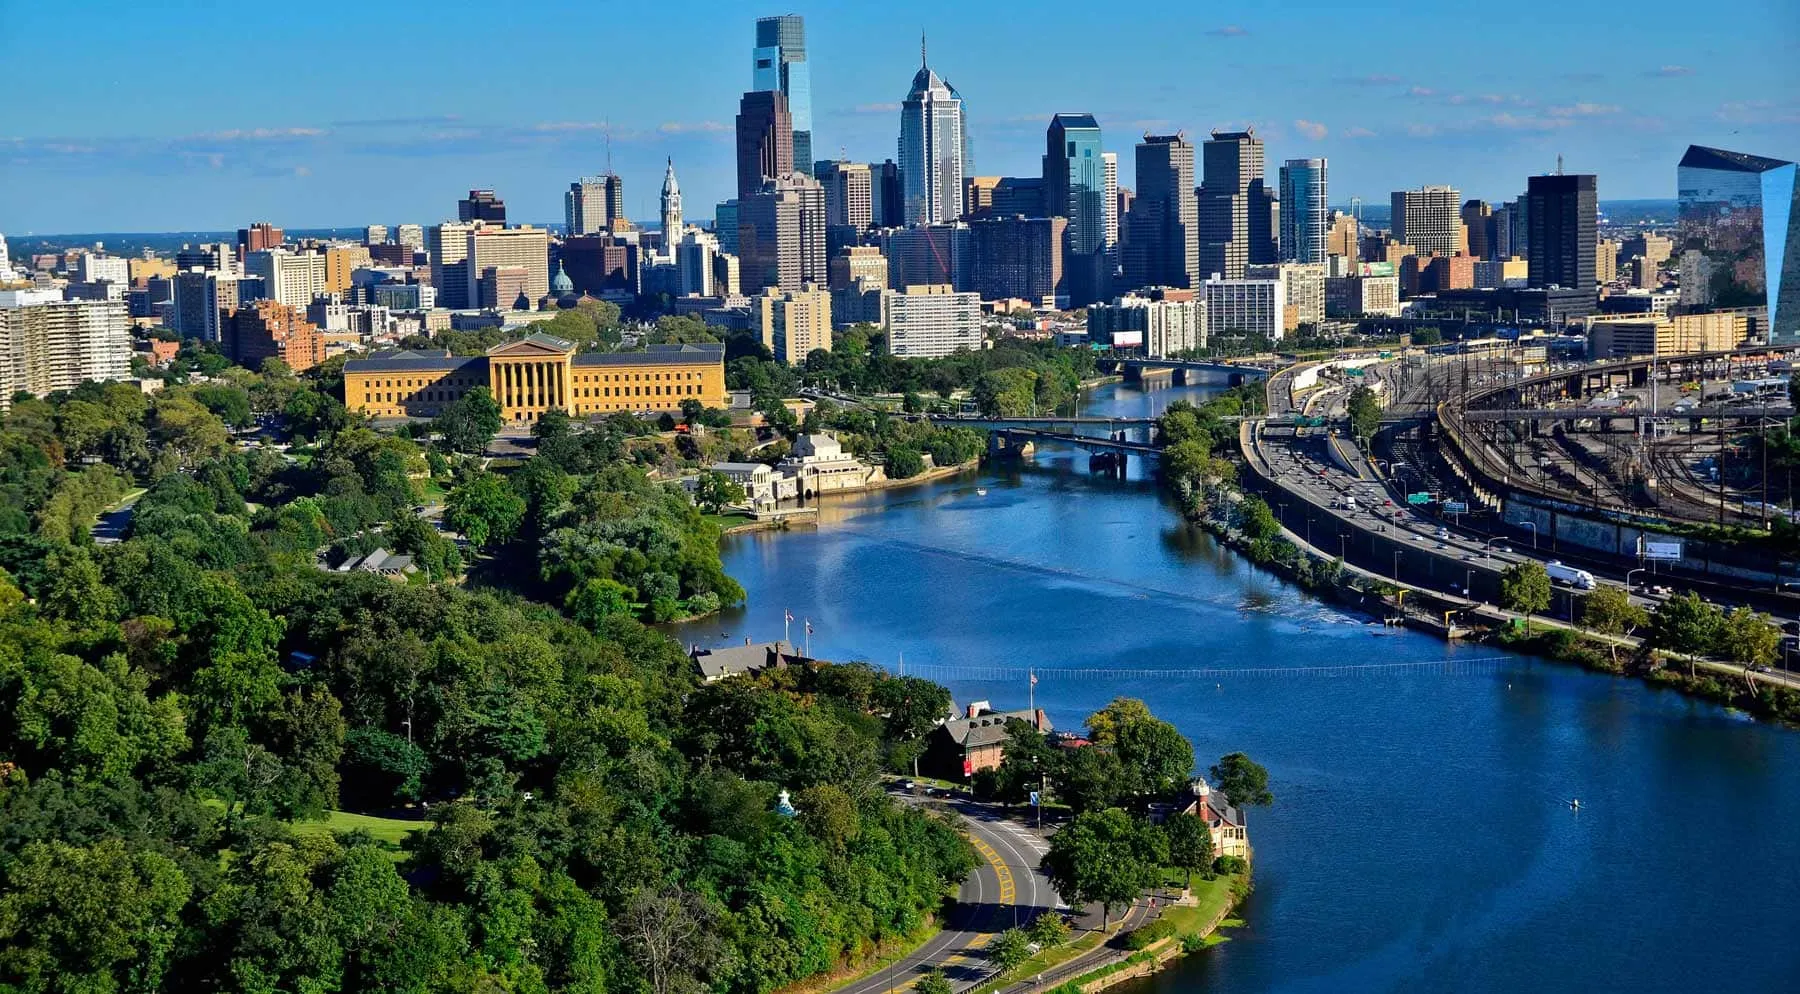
[1197,131,1276,279]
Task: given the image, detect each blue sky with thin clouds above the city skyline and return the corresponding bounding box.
[0,0,1800,234]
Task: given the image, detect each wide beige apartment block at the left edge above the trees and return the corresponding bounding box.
[0,301,131,411]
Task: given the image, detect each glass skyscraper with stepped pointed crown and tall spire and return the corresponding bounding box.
[900,43,968,225]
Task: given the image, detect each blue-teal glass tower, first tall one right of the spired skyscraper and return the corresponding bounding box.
[1044,113,1109,308]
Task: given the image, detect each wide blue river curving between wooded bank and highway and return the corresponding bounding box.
[677,378,1800,994]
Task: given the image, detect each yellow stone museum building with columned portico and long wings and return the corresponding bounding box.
[344,335,729,421]
